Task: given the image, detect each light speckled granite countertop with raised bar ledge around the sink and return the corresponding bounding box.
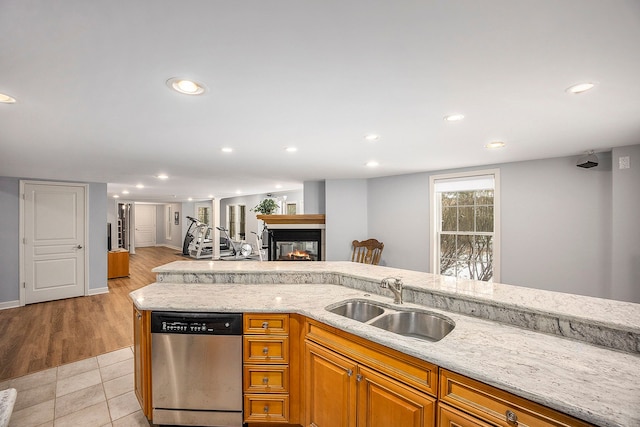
[131,261,640,426]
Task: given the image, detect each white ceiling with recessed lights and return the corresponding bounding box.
[0,0,640,201]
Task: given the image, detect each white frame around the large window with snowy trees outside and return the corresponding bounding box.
[429,169,501,283]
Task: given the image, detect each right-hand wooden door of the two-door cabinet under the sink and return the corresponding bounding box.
[357,366,436,427]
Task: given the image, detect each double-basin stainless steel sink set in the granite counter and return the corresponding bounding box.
[326,300,456,341]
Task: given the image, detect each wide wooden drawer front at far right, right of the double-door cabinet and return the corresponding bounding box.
[439,369,591,427]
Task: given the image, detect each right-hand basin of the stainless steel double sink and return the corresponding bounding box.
[370,311,456,341]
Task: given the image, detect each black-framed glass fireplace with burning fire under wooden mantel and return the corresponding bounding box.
[269,228,322,261]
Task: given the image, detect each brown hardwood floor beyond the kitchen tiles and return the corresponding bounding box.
[0,247,185,380]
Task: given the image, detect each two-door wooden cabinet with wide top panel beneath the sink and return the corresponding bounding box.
[305,321,436,427]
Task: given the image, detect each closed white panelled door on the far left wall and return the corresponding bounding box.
[22,183,86,304]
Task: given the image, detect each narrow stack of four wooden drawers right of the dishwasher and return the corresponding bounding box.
[243,313,290,423]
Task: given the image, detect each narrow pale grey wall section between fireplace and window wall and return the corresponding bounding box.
[325,179,369,261]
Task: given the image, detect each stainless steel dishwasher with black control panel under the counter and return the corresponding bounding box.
[151,312,243,427]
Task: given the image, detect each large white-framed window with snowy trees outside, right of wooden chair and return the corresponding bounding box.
[430,170,500,282]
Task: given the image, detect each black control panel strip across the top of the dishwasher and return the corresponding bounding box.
[151,311,242,335]
